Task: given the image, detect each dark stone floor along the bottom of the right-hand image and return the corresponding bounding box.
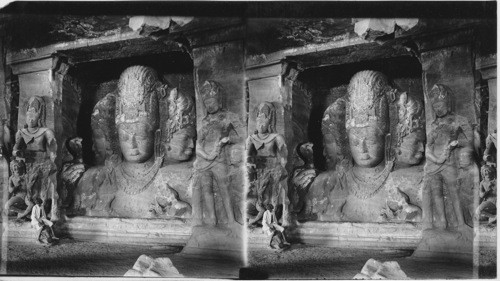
[249,245,496,279]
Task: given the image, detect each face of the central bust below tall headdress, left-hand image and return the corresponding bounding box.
[118,122,155,163]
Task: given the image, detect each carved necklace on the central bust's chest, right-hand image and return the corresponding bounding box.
[346,161,394,199]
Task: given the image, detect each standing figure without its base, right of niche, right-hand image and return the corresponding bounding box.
[422,84,474,229]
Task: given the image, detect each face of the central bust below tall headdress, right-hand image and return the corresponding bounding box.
[348,127,385,168]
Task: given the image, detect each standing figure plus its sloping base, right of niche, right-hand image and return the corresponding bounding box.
[413,84,478,261]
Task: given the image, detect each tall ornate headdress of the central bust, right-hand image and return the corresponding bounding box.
[346,70,392,132]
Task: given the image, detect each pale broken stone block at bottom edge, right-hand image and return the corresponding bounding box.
[353,259,409,280]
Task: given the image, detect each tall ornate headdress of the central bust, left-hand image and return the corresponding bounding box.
[115,65,162,129]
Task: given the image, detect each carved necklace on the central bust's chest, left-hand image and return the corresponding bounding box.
[115,157,163,195]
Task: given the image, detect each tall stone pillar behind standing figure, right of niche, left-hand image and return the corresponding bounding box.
[182,25,247,262]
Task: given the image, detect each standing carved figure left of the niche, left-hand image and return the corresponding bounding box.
[13,96,59,221]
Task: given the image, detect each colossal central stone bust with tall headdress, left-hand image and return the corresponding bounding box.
[73,66,192,218]
